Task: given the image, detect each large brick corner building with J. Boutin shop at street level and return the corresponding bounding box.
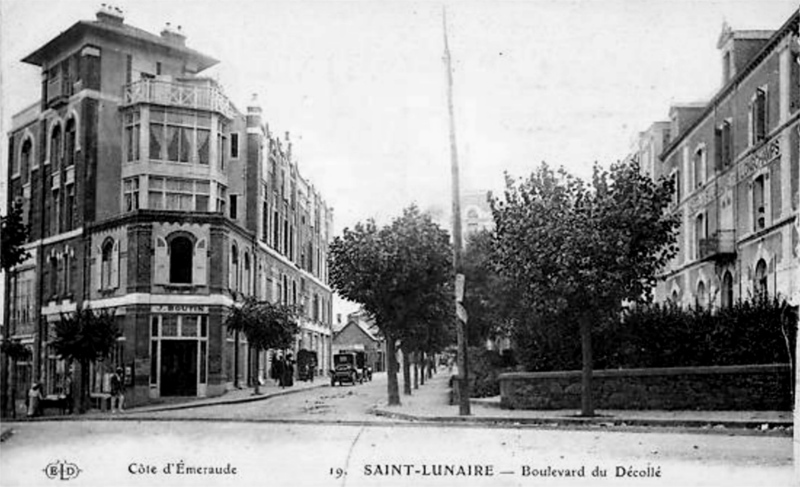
[3,7,332,405]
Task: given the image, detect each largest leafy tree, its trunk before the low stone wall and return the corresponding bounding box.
[492,163,679,416]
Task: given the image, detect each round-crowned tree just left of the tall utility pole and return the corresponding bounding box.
[329,205,453,405]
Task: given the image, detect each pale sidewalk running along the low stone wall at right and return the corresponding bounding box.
[373,372,793,433]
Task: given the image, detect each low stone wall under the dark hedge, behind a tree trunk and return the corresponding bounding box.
[500,364,793,411]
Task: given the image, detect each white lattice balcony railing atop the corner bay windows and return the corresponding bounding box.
[122,78,236,119]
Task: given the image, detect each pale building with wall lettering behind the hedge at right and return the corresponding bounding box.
[643,18,800,307]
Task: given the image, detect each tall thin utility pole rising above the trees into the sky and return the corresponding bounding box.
[442,8,470,416]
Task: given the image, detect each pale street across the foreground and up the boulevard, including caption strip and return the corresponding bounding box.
[0,374,794,486]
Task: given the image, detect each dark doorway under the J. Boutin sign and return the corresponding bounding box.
[161,340,197,396]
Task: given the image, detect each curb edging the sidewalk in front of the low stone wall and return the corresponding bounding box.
[370,407,793,430]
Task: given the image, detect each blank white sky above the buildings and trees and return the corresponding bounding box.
[0,0,800,318]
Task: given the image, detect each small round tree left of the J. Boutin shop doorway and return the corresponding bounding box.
[50,307,120,413]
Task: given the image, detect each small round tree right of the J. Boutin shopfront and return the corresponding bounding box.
[225,296,300,394]
